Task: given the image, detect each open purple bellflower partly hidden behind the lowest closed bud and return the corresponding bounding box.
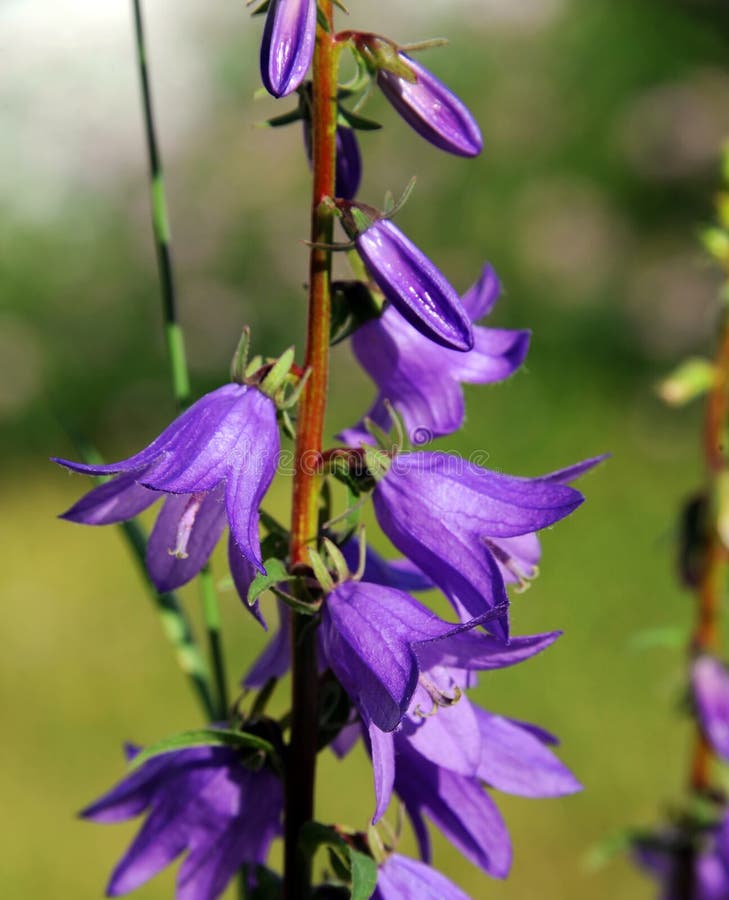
[341,265,529,444]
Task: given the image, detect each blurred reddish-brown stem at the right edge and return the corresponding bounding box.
[690,310,729,793]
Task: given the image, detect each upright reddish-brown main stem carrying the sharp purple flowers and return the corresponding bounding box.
[284,0,338,900]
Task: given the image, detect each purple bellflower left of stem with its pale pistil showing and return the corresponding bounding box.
[55,384,280,591]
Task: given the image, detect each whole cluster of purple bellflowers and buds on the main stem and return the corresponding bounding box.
[56,0,600,900]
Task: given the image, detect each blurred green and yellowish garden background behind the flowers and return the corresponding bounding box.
[0,0,729,900]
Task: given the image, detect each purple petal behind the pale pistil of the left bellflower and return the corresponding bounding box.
[147,488,225,593]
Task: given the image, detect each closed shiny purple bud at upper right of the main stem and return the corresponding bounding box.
[377,53,483,156]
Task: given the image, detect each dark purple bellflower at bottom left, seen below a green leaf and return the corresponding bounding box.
[81,747,283,900]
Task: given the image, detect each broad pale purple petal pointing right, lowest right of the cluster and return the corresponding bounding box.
[475,707,582,797]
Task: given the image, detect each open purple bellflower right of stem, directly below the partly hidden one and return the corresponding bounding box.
[373,452,584,638]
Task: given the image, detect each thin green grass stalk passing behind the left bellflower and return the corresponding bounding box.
[132,0,228,719]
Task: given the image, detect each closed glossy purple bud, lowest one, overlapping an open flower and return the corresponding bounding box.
[337,200,474,351]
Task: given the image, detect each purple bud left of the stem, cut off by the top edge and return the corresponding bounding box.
[261,0,316,97]
